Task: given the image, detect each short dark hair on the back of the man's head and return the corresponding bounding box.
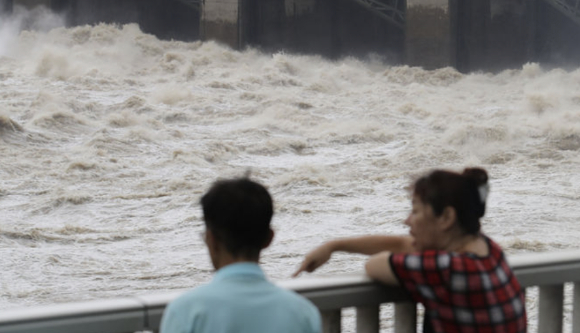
[201,178,274,259]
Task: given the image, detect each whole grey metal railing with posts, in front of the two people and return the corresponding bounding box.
[0,251,580,333]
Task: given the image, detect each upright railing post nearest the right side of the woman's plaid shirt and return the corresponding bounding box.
[538,284,564,333]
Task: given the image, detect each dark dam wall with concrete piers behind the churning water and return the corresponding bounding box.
[0,0,580,72]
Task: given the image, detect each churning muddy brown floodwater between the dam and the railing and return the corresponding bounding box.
[0,6,580,330]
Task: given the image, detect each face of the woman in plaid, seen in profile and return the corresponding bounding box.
[405,195,440,251]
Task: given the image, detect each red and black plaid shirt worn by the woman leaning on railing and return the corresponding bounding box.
[389,236,527,333]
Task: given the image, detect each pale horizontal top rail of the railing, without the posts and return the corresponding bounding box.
[0,250,580,333]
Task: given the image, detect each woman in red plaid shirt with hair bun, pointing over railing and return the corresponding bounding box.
[294,168,527,333]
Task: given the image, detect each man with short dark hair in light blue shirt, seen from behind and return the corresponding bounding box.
[161,178,321,333]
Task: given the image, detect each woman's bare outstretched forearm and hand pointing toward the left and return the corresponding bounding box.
[292,236,413,277]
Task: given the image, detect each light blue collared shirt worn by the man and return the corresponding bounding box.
[161,262,322,333]
